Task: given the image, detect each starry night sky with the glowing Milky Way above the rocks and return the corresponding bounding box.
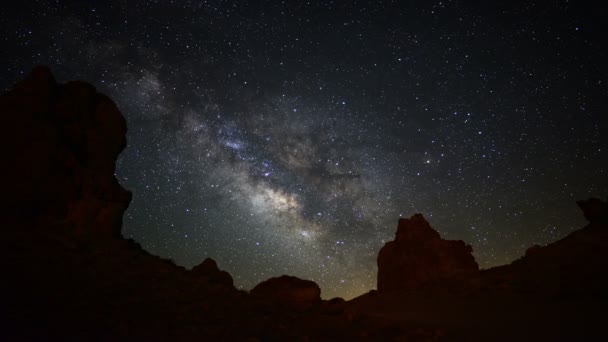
[0,1,608,298]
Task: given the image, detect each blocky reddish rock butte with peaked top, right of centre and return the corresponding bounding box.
[378,214,479,292]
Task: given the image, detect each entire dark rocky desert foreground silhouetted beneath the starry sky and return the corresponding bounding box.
[0,67,608,341]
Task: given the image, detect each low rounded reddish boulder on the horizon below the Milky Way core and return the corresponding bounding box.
[250,275,321,310]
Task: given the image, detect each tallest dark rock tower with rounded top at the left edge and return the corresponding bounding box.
[0,67,131,236]
